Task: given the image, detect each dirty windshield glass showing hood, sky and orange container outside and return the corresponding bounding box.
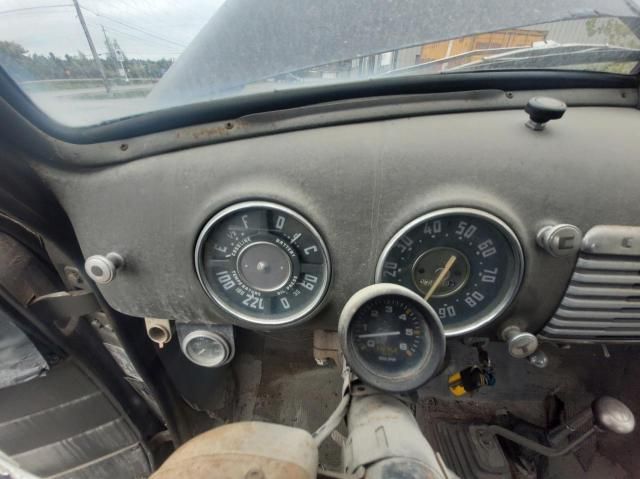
[0,0,640,126]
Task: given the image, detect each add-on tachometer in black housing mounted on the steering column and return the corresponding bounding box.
[338,284,445,392]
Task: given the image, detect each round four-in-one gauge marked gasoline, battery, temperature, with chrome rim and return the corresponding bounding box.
[196,201,330,327]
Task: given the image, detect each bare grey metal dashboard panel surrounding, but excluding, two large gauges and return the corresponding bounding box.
[33,94,640,333]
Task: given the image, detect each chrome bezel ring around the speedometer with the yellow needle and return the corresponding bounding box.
[374,207,525,337]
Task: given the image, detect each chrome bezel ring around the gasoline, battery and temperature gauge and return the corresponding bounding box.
[194,200,331,328]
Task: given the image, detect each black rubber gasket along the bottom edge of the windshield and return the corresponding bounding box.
[0,68,639,144]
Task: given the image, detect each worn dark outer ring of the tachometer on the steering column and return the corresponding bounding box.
[338,283,447,393]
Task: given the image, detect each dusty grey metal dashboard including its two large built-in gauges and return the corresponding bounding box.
[33,98,640,337]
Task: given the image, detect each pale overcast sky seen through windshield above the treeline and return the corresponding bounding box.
[0,0,224,60]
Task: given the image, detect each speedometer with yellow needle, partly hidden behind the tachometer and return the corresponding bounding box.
[376,208,524,336]
